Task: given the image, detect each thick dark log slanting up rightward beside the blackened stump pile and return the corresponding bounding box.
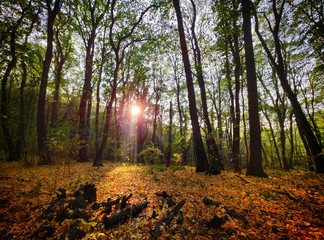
[103,201,148,230]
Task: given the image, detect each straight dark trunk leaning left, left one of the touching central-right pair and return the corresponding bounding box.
[173,0,208,172]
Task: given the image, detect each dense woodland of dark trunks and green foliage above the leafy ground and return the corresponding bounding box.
[0,0,324,176]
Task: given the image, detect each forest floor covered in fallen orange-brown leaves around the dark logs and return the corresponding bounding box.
[0,162,324,239]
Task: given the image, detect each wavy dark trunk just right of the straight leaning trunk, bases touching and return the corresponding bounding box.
[191,0,223,174]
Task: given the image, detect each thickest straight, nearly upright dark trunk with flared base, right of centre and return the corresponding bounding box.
[242,0,267,177]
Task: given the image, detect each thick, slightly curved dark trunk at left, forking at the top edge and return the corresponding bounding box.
[37,0,61,164]
